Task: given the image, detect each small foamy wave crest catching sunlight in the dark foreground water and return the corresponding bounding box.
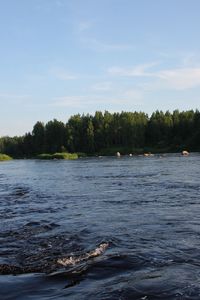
[57,243,109,267]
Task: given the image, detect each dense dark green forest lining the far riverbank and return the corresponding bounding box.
[0,110,200,157]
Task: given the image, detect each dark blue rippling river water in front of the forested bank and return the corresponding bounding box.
[0,154,200,300]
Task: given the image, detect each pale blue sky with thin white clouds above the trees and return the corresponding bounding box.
[0,0,200,136]
